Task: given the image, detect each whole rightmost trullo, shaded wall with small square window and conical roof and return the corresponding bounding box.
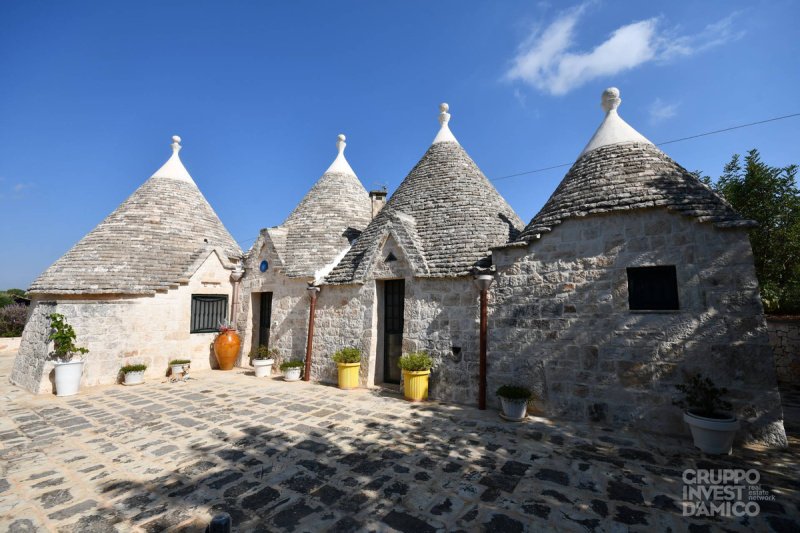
[489,88,786,446]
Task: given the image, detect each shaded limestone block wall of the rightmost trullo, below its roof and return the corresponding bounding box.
[488,210,786,445]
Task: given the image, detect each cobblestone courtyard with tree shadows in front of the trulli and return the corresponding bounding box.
[0,355,800,533]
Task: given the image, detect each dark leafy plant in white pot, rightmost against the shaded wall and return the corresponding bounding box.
[672,374,739,455]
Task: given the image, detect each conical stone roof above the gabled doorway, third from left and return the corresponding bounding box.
[326,104,522,283]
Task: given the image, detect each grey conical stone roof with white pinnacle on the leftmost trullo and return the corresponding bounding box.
[29,136,241,294]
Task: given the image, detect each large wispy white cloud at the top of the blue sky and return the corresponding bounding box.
[506,2,743,95]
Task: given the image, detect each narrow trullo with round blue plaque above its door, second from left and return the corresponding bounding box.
[237,135,376,370]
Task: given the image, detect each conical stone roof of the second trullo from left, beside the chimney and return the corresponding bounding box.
[278,135,372,278]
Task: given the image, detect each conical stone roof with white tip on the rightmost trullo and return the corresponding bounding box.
[518,87,754,241]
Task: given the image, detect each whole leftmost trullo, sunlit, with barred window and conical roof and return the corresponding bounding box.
[11,136,241,392]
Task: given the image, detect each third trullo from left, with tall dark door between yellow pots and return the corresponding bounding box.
[324,104,522,403]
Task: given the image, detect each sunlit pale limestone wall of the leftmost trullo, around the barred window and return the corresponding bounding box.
[11,253,232,393]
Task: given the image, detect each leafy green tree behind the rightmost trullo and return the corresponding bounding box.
[701,150,800,314]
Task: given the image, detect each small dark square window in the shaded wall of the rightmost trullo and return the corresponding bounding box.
[627,265,680,311]
